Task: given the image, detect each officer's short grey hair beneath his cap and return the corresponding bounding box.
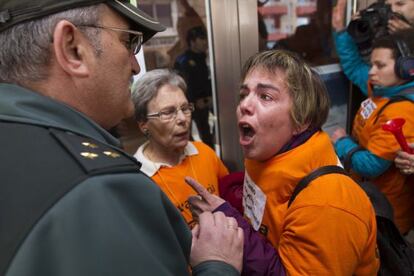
[0,5,101,85]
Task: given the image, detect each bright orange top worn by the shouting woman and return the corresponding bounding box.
[245,132,379,275]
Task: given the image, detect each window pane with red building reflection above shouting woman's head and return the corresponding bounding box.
[258,0,337,65]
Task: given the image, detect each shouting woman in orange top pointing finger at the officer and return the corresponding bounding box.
[187,51,379,275]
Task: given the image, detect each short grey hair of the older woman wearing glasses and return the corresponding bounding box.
[132,69,187,122]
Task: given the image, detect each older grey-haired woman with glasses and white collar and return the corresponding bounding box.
[132,70,228,226]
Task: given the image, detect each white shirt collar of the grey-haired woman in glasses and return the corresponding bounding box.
[134,141,198,177]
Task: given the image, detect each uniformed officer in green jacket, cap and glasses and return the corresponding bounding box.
[0,0,243,276]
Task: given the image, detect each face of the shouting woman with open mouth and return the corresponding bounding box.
[237,68,296,161]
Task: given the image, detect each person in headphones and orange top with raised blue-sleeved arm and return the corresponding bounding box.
[332,0,414,234]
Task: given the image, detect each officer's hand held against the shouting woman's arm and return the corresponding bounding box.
[190,212,243,272]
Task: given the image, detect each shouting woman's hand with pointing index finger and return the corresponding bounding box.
[185,176,226,220]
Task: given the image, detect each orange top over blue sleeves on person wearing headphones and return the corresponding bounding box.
[352,97,414,233]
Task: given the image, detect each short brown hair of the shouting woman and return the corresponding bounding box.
[241,50,330,129]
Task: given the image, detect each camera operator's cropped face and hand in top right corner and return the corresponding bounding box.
[387,0,414,33]
